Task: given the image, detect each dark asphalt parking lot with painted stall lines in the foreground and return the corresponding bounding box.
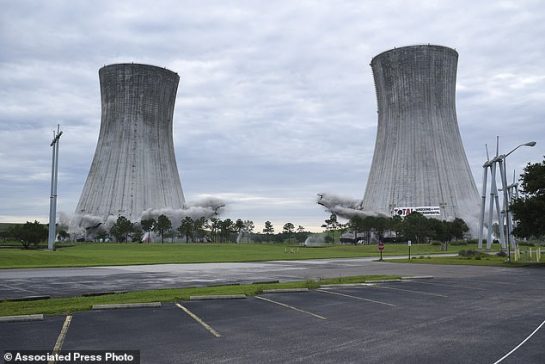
[0,269,545,363]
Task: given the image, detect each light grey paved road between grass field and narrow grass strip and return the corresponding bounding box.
[0,258,523,299]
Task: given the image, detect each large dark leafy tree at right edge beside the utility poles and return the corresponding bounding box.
[509,159,545,239]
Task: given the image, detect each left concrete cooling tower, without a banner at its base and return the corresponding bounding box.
[76,64,184,221]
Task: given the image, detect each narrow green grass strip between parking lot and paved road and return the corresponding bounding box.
[0,275,400,316]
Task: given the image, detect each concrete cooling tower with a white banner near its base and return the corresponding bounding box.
[362,45,479,223]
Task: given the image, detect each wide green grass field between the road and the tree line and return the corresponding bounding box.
[0,243,492,268]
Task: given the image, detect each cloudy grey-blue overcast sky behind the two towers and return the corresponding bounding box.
[0,0,545,231]
